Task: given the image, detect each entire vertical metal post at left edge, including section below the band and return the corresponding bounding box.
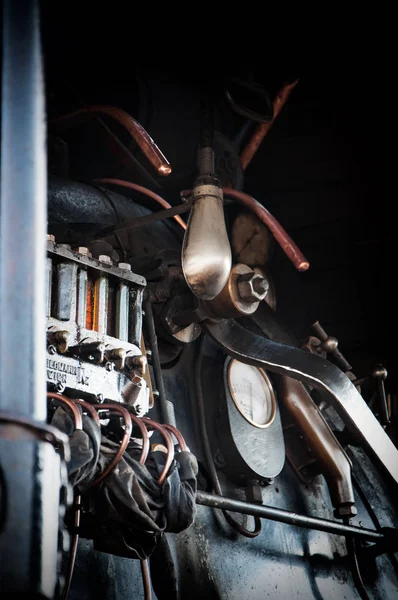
[0,0,60,598]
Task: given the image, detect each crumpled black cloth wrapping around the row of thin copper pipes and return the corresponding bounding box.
[52,408,198,559]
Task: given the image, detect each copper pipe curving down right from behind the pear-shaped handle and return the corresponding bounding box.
[223,188,310,271]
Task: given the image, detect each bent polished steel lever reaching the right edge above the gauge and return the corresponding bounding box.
[204,320,398,483]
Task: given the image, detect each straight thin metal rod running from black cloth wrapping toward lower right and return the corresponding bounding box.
[196,492,388,542]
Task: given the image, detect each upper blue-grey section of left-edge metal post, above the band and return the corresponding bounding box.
[0,0,47,421]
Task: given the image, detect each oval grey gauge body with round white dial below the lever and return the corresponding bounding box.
[203,355,285,485]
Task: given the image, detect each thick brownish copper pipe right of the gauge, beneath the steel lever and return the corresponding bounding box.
[276,376,355,516]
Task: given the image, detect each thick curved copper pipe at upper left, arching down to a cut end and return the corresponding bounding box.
[50,105,171,175]
